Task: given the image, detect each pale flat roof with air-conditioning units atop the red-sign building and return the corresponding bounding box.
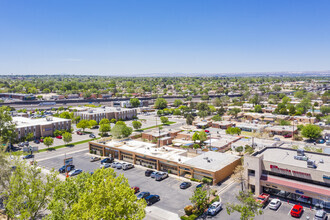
[257,148,330,173]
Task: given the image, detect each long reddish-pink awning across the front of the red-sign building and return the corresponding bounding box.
[260,175,330,197]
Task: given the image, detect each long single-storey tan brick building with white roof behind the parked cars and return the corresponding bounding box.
[89,139,240,184]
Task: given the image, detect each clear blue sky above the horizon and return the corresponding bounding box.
[0,0,330,75]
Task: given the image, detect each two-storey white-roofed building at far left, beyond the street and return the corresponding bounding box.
[13,116,71,140]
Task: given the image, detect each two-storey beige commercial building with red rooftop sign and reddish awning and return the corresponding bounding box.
[244,147,330,209]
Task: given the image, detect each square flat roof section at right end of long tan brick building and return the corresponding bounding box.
[183,151,240,172]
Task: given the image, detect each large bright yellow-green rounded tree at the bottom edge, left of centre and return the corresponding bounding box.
[47,169,146,220]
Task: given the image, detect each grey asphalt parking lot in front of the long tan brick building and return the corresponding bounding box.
[35,146,197,214]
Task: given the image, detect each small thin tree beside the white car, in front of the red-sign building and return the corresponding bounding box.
[226,191,263,220]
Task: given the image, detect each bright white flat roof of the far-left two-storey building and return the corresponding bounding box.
[13,116,71,128]
